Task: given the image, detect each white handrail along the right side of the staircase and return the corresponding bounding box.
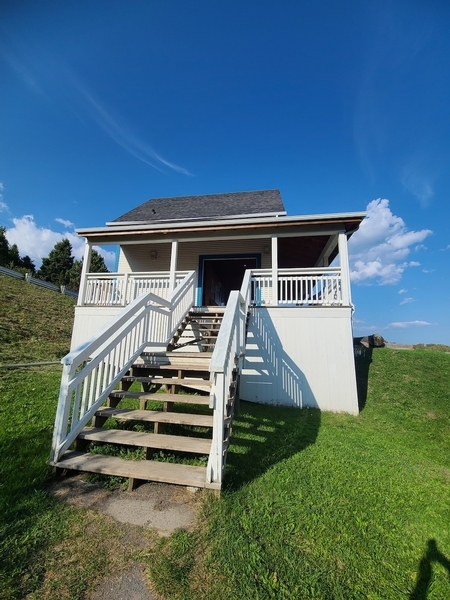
[206,271,251,486]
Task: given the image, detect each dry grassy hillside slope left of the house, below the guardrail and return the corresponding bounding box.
[0,274,76,365]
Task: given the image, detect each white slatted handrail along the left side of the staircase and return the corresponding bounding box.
[50,271,195,464]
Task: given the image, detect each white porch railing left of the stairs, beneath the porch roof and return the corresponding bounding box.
[79,271,187,306]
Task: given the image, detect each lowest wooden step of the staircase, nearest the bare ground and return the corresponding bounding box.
[55,452,220,489]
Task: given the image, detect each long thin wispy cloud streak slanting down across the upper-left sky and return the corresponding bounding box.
[0,39,191,175]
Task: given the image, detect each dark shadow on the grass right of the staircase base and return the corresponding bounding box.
[224,401,321,491]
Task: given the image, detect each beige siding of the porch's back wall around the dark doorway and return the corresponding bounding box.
[117,238,272,273]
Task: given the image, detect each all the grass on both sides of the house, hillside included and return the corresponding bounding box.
[0,276,450,600]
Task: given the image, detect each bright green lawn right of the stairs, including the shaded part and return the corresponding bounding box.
[149,349,450,600]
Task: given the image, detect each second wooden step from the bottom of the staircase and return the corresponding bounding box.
[78,427,211,454]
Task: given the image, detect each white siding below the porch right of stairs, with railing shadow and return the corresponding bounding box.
[240,307,358,414]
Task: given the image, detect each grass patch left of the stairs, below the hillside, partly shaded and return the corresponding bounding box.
[0,369,150,600]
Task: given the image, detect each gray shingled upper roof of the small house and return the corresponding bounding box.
[112,190,285,223]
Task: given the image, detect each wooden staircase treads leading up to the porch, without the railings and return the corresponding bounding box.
[55,307,238,490]
